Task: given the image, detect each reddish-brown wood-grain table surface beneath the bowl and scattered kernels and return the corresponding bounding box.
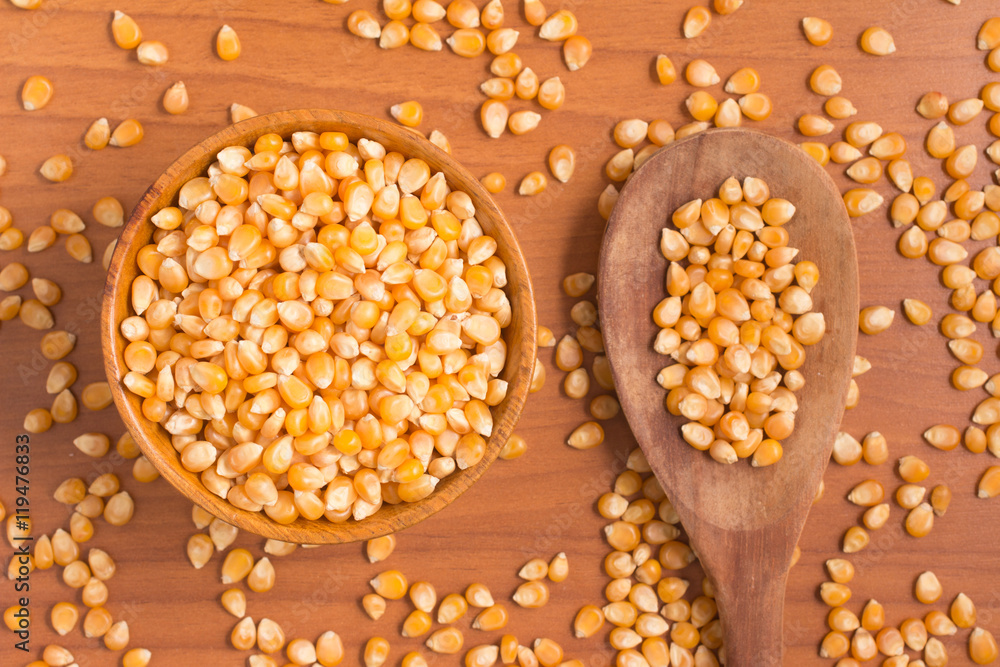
[0,0,1000,666]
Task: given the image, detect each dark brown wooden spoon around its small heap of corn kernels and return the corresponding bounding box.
[599,129,858,667]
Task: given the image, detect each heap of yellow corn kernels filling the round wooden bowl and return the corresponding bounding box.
[120,132,511,524]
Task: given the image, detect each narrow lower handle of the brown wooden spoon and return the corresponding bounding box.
[699,523,797,667]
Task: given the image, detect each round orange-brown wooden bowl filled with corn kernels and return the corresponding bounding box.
[101,109,536,544]
